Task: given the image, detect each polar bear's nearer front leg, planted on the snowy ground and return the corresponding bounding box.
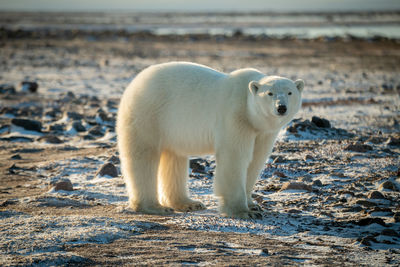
[214,142,262,219]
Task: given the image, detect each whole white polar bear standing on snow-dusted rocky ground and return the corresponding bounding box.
[116,62,304,219]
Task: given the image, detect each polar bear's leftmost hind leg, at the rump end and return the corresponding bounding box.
[120,144,173,215]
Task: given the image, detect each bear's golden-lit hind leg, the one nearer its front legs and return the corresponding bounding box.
[158,151,206,212]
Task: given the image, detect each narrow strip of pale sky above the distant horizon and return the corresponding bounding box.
[0,0,400,12]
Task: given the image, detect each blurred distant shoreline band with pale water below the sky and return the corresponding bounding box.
[0,11,400,40]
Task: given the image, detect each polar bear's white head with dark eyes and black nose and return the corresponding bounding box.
[249,76,304,130]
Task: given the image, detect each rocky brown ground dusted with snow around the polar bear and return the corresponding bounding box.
[0,25,400,266]
